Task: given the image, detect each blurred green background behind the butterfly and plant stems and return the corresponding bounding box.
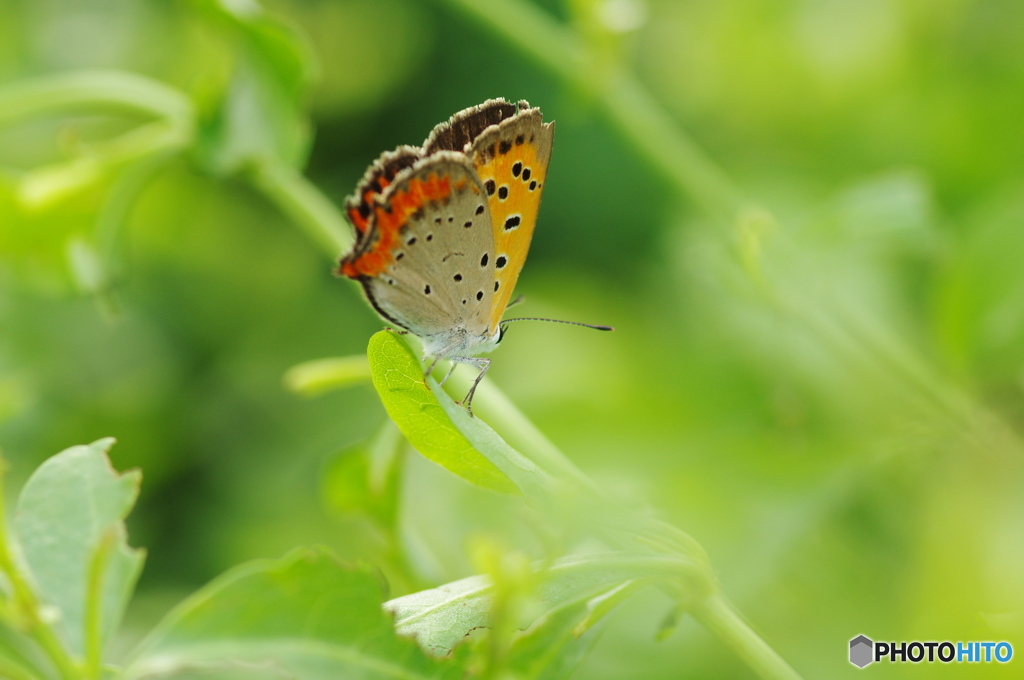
[0,0,1024,679]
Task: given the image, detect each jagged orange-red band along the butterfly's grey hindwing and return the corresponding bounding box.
[341,174,452,279]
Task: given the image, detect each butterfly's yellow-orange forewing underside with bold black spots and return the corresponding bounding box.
[468,109,554,331]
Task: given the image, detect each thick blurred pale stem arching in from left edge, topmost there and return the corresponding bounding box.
[0,71,193,125]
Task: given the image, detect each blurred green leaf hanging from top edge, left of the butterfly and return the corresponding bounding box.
[196,0,313,174]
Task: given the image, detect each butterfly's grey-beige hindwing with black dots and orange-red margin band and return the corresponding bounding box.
[350,156,495,336]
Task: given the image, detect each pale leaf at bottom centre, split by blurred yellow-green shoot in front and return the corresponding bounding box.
[384,553,702,656]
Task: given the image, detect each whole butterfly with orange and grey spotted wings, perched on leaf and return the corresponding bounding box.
[338,98,610,414]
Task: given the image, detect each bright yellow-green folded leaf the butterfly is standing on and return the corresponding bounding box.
[367,331,532,494]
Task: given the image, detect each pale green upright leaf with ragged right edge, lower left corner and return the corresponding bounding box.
[14,438,143,661]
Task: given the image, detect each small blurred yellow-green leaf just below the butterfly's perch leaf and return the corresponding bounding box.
[324,420,406,526]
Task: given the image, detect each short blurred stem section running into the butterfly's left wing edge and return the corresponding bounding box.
[251,163,352,257]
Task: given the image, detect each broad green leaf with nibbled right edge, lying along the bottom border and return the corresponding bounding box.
[125,549,458,680]
